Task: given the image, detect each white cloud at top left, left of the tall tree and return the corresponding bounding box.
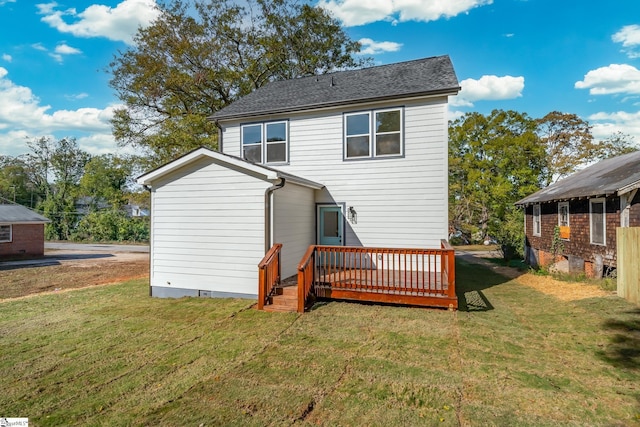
[37,0,160,44]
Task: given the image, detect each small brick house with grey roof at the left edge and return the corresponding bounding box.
[0,204,50,259]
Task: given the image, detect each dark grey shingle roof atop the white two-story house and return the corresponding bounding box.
[210,55,460,120]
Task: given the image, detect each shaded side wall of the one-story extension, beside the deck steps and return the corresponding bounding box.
[273,183,315,279]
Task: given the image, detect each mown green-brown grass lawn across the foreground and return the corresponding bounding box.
[0,263,640,426]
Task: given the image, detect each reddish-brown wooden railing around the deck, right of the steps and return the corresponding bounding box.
[298,241,458,311]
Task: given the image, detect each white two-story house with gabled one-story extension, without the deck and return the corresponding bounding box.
[138,56,459,304]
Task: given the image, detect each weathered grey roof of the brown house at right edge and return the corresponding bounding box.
[516,151,640,205]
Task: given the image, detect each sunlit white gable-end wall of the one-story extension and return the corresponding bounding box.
[151,160,270,295]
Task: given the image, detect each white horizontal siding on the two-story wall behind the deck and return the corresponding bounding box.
[223,97,448,251]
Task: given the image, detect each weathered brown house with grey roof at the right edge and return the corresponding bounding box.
[516,151,640,277]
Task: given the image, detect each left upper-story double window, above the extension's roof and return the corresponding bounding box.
[241,121,289,167]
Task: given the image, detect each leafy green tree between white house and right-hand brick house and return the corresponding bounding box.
[449,110,545,254]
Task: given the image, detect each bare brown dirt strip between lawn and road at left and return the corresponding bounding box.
[0,251,149,301]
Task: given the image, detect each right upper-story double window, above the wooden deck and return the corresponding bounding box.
[344,108,403,159]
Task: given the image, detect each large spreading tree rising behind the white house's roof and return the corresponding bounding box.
[109,0,369,164]
